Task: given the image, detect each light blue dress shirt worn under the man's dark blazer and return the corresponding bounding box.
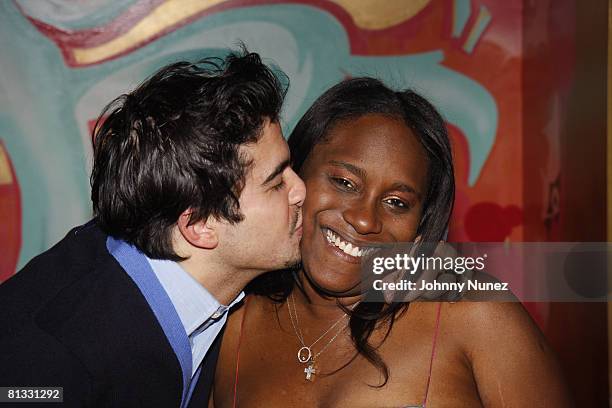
[147,257,244,377]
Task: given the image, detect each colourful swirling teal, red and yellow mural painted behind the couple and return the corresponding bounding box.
[0,0,571,281]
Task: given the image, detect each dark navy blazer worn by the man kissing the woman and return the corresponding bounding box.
[0,222,222,408]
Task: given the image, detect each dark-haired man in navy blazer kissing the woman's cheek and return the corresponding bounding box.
[0,52,305,407]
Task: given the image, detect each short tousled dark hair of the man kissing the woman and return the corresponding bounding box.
[91,49,286,260]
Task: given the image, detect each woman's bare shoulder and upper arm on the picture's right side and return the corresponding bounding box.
[438,301,571,407]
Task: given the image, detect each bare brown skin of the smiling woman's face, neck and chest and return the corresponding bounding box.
[210,115,570,408]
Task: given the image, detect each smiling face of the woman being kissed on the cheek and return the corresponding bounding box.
[301,114,428,296]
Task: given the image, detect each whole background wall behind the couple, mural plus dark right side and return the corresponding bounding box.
[0,0,607,406]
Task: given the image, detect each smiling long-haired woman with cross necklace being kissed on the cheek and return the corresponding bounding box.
[211,78,569,408]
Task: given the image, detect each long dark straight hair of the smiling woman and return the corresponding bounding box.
[248,78,455,387]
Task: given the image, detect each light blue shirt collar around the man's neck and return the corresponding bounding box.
[147,257,244,336]
